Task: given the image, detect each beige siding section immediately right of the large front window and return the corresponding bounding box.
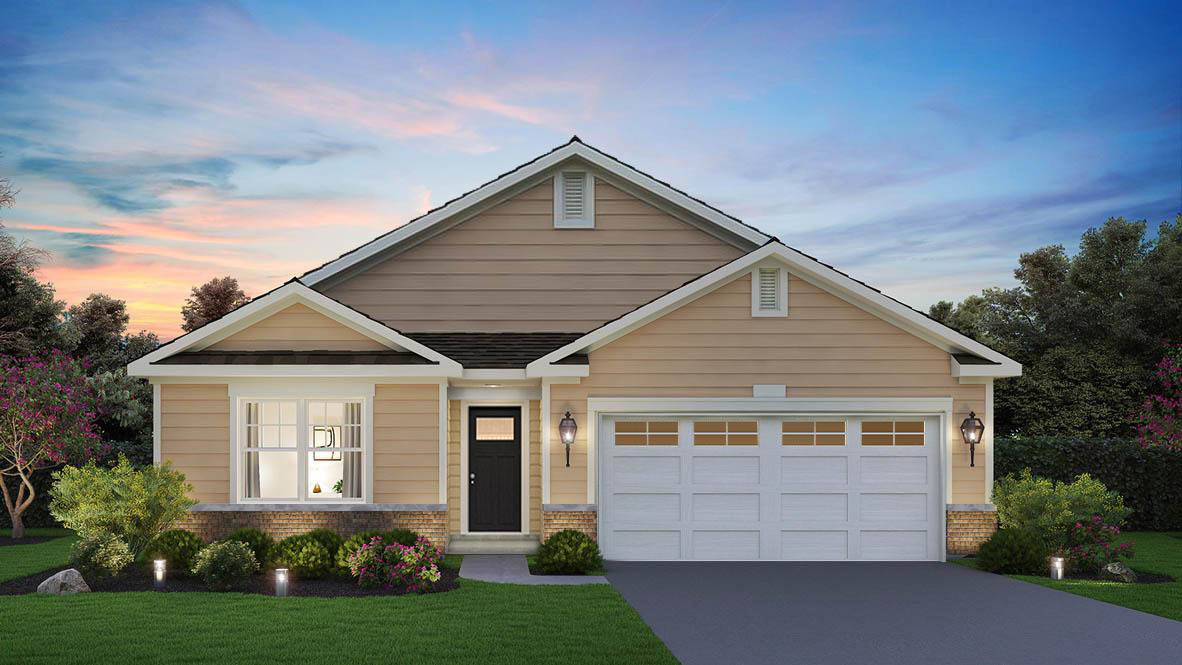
[374,384,440,503]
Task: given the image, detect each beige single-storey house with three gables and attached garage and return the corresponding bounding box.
[129,137,1021,560]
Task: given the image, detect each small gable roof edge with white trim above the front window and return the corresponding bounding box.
[128,280,461,377]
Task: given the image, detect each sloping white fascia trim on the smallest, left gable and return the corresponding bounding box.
[128,281,461,377]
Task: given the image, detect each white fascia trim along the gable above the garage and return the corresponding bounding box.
[526,242,1021,377]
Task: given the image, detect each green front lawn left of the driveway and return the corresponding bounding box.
[0,539,676,665]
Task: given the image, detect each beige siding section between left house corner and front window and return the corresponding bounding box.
[160,384,229,503]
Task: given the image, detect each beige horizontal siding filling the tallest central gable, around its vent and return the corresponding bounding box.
[325,181,743,332]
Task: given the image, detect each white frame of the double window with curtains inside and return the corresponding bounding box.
[230,386,374,504]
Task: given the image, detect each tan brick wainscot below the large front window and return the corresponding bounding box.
[176,510,448,549]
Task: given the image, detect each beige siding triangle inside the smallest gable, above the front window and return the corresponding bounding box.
[209,305,387,351]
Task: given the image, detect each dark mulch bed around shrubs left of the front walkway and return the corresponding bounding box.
[0,567,460,598]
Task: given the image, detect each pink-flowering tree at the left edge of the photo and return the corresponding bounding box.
[0,352,103,537]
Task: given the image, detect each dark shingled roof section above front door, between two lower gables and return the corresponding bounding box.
[402,332,587,370]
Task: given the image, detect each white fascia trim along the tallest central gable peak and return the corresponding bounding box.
[301,143,771,286]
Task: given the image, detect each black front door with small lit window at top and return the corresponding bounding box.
[468,406,521,532]
